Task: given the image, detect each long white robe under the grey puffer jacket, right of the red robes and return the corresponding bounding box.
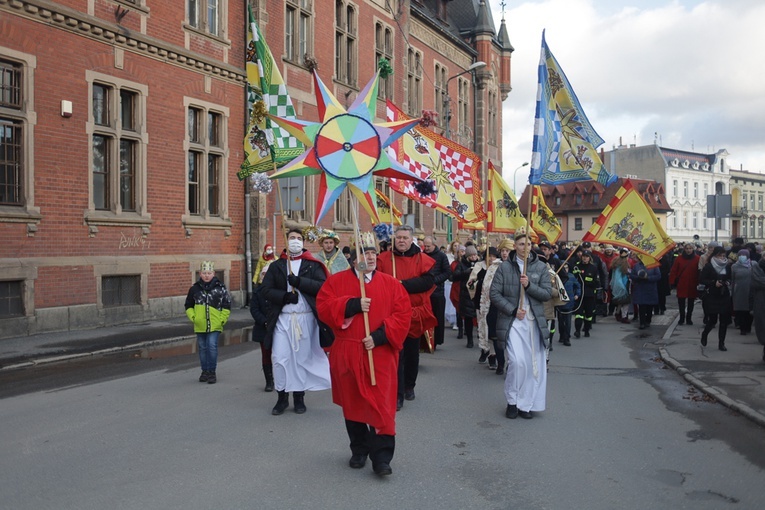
[505,260,547,411]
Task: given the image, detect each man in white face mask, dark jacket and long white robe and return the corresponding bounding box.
[263,228,331,415]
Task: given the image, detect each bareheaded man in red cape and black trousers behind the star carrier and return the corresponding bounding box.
[377,225,438,409]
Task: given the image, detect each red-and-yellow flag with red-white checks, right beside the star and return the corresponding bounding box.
[387,101,486,223]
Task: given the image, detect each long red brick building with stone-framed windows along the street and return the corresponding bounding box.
[0,0,513,338]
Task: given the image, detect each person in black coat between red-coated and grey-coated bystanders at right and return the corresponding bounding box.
[699,246,731,351]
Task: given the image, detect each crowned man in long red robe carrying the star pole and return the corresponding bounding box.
[316,236,412,476]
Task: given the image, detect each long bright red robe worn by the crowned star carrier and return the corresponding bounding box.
[316,269,412,435]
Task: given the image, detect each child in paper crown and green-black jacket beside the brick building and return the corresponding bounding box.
[184,260,231,384]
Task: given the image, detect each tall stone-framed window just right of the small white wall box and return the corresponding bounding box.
[86,71,150,224]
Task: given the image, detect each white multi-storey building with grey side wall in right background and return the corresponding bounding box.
[603,145,735,242]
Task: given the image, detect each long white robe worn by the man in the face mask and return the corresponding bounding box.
[271,260,332,392]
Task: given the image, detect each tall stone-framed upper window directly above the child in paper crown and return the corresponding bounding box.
[184,98,229,222]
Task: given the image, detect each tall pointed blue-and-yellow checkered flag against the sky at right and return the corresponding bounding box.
[529,31,617,186]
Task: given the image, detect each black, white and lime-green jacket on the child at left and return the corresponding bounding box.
[185,277,231,333]
